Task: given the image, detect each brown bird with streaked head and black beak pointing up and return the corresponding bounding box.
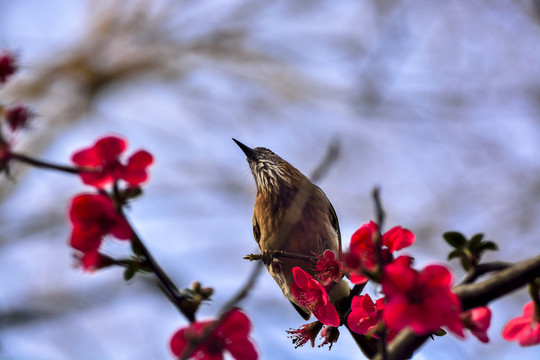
[233,138,350,320]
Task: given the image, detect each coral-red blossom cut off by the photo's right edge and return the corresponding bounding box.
[502,301,540,346]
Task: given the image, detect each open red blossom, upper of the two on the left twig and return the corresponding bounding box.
[71,136,154,188]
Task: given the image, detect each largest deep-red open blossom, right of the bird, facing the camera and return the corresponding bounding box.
[381,256,464,337]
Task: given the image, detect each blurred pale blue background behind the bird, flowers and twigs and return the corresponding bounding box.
[0,0,540,360]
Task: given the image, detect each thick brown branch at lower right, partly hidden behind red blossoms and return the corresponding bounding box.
[373,255,540,360]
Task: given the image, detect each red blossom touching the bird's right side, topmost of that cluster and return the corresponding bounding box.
[344,221,415,284]
